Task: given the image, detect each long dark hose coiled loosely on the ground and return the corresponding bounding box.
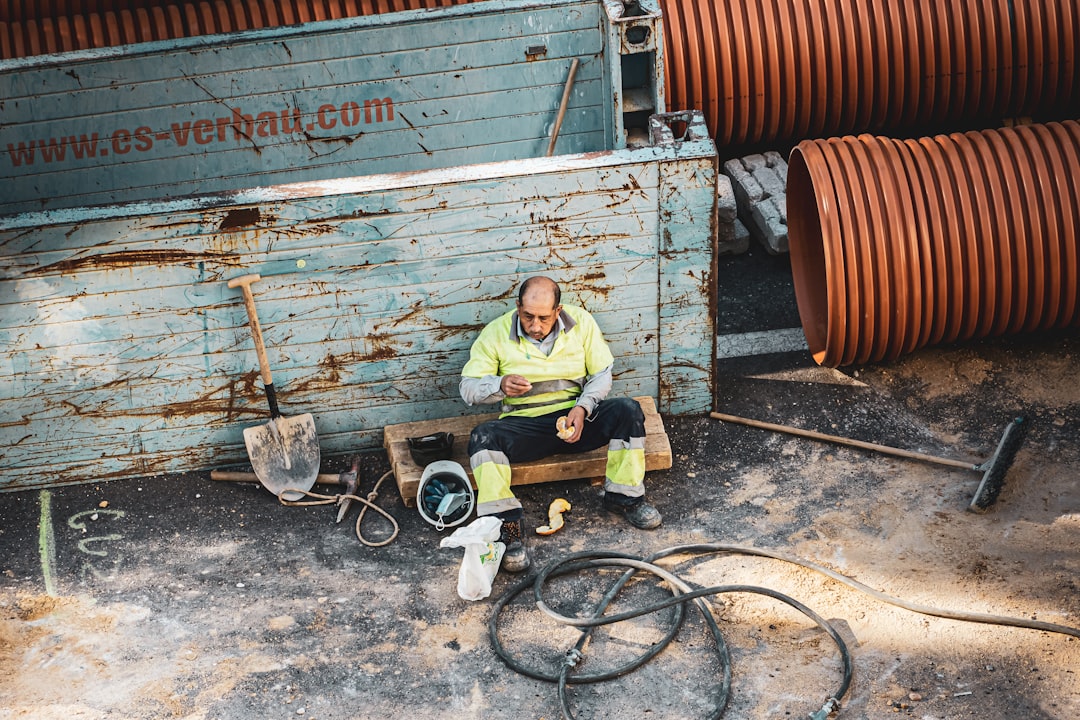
[488,543,1080,720]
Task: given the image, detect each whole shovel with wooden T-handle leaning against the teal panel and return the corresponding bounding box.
[223,274,320,501]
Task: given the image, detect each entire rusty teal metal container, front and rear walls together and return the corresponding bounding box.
[0,0,718,490]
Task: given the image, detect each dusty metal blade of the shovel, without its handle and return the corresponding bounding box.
[244,412,321,500]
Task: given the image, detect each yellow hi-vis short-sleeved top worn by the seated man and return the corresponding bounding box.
[461,305,615,417]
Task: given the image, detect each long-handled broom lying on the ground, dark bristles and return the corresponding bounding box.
[708,412,1029,513]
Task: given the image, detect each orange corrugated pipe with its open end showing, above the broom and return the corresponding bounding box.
[787,121,1080,367]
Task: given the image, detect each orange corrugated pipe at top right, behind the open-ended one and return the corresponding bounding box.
[660,0,1080,147]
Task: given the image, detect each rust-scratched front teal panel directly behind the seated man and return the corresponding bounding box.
[0,1,717,489]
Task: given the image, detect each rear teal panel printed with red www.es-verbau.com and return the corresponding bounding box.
[0,0,618,213]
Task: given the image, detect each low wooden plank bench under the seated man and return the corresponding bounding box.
[382,396,672,507]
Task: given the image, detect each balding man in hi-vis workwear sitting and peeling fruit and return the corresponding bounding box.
[460,275,661,572]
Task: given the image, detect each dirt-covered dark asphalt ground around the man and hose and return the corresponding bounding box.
[0,250,1080,720]
